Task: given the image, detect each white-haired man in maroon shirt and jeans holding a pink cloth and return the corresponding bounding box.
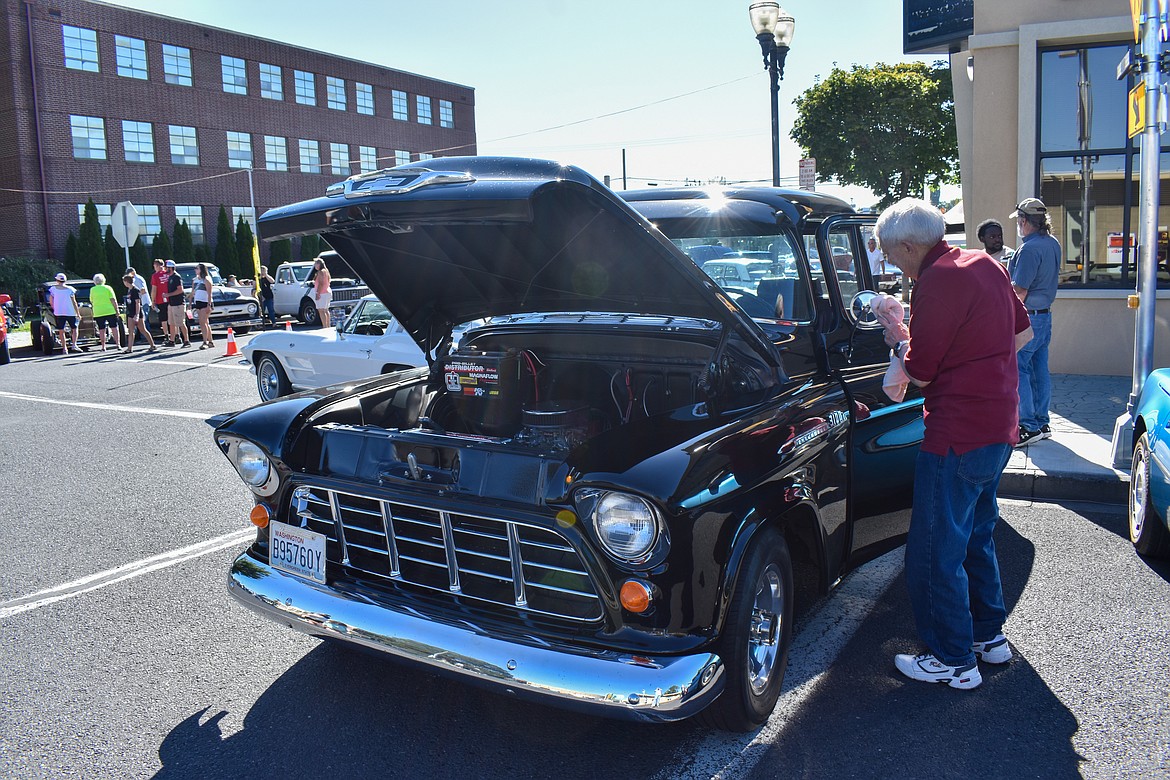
[876,198,1030,689]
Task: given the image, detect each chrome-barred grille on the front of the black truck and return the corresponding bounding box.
[290,485,601,621]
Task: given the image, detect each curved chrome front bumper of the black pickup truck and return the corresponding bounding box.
[228,552,724,722]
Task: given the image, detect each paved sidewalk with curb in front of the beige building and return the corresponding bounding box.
[999,374,1133,504]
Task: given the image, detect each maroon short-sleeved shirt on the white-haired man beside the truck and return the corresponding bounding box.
[906,241,1030,455]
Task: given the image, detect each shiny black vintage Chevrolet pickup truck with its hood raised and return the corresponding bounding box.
[217,158,923,730]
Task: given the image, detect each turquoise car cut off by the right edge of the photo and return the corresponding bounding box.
[1129,368,1170,559]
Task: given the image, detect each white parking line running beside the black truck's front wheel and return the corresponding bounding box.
[655,547,906,780]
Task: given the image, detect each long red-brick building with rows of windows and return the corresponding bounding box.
[0,0,475,258]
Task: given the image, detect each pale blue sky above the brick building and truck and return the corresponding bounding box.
[98,0,941,207]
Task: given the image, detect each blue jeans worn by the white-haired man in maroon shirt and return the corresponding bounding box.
[906,444,1012,667]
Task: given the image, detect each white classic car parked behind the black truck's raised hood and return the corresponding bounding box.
[241,295,427,401]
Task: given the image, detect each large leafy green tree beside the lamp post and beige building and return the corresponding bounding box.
[792,62,958,207]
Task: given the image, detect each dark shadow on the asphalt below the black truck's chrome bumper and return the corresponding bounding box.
[156,643,696,780]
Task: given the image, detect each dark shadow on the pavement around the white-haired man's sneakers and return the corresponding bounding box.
[750,514,1080,780]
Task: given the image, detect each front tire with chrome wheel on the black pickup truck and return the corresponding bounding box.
[697,530,792,732]
